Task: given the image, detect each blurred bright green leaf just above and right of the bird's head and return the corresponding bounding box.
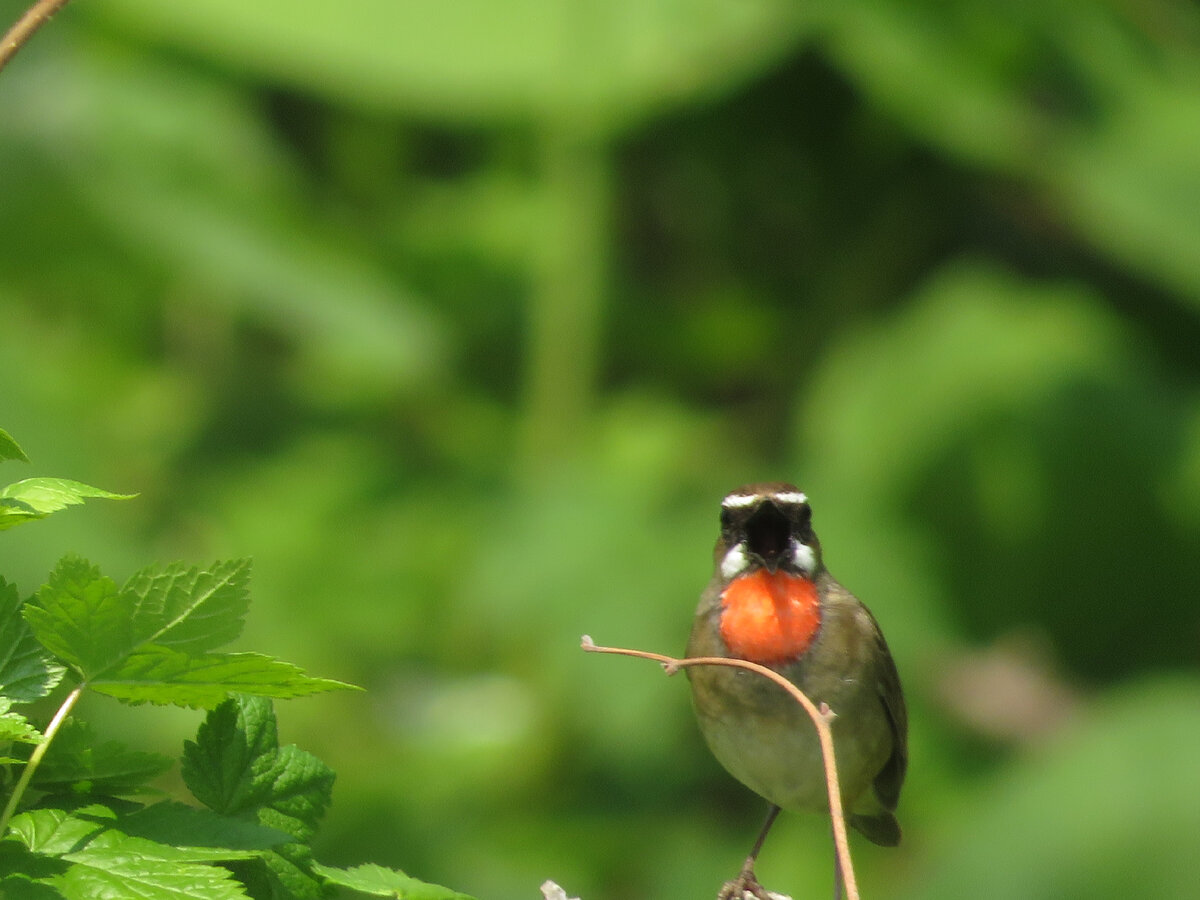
[804,260,1122,502]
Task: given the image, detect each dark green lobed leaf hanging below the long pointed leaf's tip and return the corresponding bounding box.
[181,697,334,841]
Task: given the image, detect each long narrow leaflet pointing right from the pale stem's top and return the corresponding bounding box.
[90,644,358,709]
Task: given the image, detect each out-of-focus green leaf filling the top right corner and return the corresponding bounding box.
[829,0,1200,300]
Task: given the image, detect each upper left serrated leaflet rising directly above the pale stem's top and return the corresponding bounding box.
[22,557,134,680]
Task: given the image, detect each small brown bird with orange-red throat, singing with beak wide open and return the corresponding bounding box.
[688,482,908,900]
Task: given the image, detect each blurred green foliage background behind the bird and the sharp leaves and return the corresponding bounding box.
[0,0,1200,900]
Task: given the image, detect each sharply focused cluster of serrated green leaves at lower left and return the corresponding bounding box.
[0,433,463,900]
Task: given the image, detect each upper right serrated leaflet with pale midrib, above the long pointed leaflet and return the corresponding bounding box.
[121,559,250,654]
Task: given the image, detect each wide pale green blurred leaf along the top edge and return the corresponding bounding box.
[88,0,811,127]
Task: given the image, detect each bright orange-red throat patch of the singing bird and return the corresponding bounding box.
[721,569,821,665]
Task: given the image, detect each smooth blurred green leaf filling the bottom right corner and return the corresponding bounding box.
[899,677,1200,900]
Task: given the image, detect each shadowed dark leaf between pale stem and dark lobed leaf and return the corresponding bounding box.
[34,720,174,796]
